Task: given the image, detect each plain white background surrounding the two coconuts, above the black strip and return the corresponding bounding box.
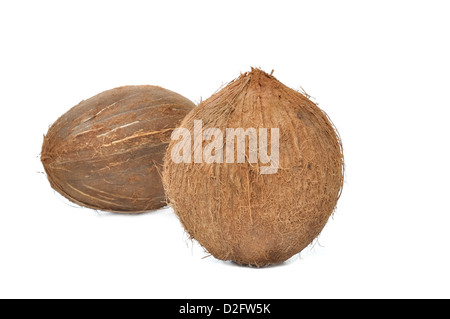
[0,0,450,298]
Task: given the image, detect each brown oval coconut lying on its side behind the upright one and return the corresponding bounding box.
[41,85,195,213]
